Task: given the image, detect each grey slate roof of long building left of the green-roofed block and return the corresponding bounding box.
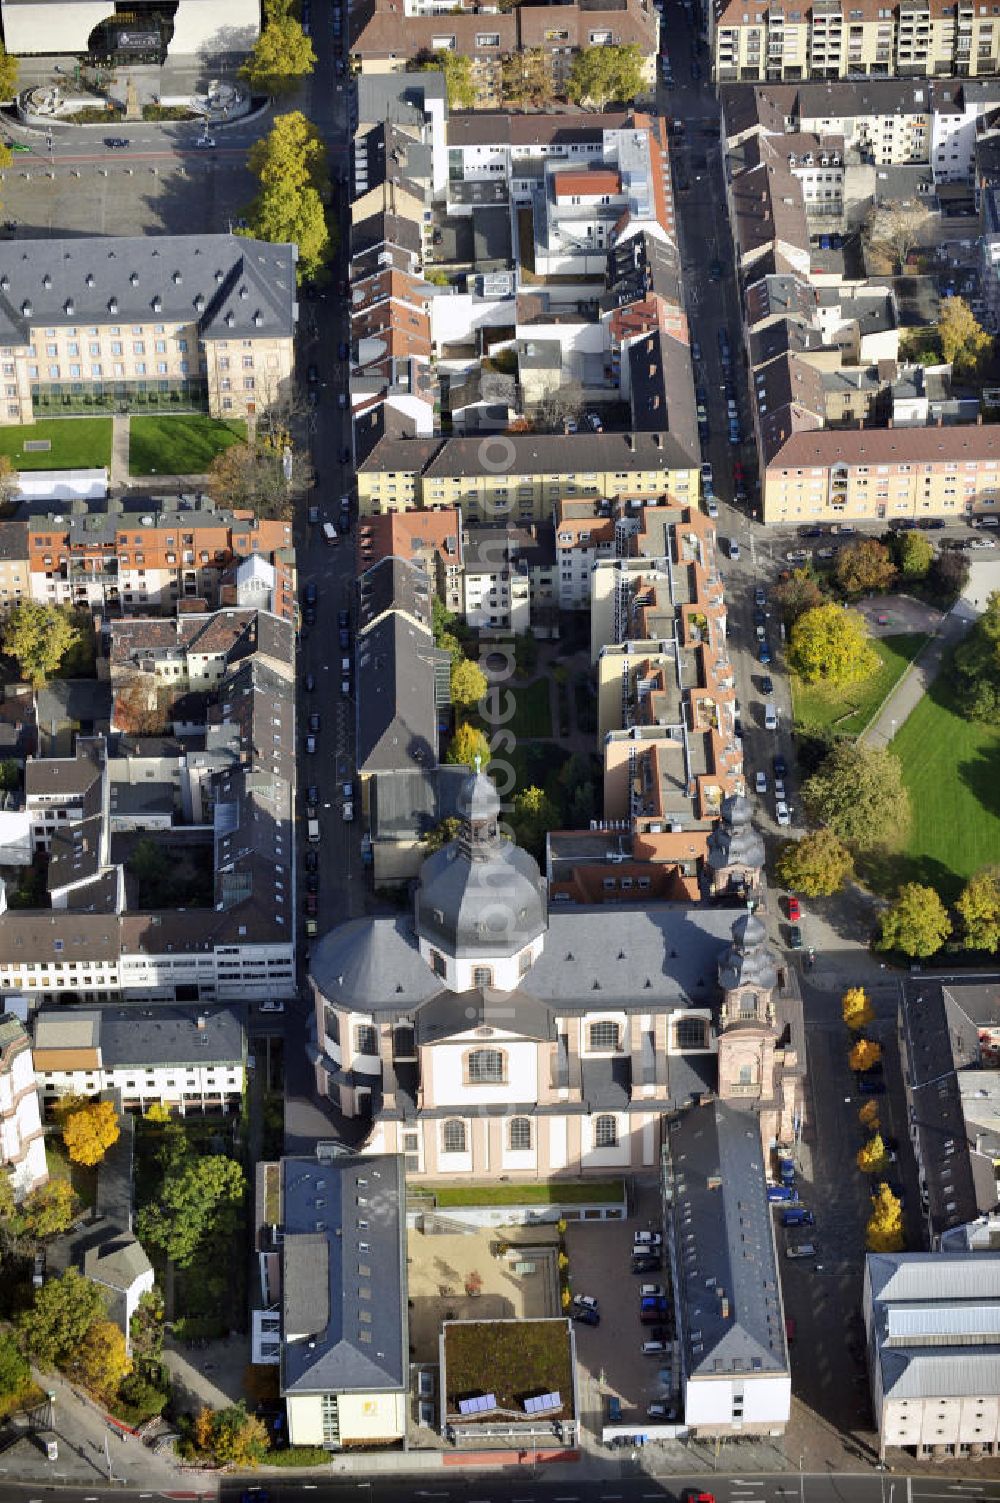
[281,1154,409,1395]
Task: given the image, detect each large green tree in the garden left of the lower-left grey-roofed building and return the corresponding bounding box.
[138,1154,247,1269]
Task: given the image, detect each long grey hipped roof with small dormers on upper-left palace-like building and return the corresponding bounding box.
[0,234,296,344]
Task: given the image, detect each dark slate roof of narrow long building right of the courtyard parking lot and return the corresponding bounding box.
[669,1100,788,1380]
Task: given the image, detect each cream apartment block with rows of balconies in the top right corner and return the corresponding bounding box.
[707,0,1000,83]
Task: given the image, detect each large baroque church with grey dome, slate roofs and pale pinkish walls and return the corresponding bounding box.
[303,774,803,1180]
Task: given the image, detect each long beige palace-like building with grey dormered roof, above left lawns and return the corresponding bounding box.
[0,234,298,425]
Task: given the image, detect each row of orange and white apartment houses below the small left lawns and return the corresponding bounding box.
[19,494,296,621]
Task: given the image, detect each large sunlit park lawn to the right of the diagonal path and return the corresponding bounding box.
[863,664,1000,903]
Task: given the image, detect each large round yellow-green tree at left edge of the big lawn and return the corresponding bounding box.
[802,741,910,851]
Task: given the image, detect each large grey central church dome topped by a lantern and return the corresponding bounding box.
[415,770,547,960]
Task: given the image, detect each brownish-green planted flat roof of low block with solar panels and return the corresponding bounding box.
[445,1318,573,1423]
